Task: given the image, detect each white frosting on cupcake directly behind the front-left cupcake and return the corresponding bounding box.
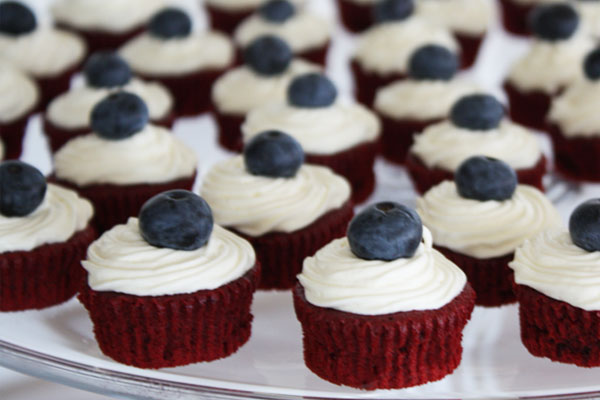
[54,125,197,186]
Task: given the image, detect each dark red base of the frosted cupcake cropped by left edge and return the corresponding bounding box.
[0,226,96,311]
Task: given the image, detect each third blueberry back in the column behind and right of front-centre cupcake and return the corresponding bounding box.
[408,44,458,81]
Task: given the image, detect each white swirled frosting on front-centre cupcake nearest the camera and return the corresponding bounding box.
[298,228,467,315]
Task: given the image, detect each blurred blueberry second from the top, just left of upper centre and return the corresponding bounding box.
[244,35,294,76]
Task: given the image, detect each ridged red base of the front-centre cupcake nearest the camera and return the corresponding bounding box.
[293,284,475,390]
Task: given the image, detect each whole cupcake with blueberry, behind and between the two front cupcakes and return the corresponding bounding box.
[201,131,353,289]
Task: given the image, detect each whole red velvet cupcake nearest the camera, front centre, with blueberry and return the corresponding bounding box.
[293,202,475,390]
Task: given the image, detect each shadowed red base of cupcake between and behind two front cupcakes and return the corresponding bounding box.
[230,202,354,290]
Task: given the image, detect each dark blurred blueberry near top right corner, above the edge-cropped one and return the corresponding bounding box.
[530,3,579,41]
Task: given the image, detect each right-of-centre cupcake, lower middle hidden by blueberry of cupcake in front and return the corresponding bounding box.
[406,95,546,193]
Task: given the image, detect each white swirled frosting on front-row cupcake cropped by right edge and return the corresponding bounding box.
[509,229,600,311]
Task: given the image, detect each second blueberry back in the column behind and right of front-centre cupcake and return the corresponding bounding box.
[450,94,504,131]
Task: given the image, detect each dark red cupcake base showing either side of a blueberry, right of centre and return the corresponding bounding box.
[405,153,546,193]
